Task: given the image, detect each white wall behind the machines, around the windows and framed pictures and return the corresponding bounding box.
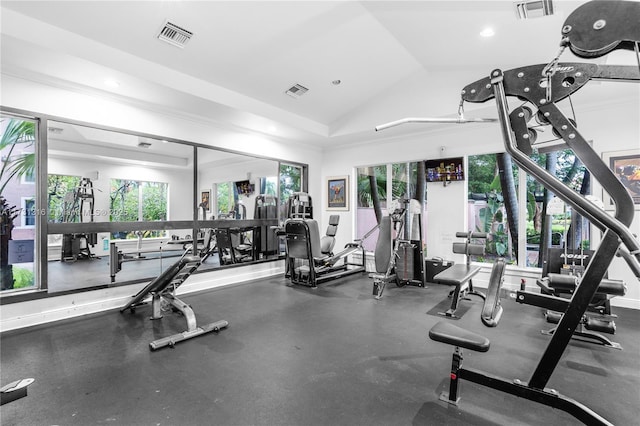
[317,92,640,309]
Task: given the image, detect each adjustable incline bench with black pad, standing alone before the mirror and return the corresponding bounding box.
[120,229,229,351]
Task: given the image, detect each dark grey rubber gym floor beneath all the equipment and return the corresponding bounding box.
[0,275,640,426]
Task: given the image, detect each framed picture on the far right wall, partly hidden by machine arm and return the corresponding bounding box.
[602,149,640,210]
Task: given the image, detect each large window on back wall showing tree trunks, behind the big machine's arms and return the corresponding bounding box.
[468,149,590,267]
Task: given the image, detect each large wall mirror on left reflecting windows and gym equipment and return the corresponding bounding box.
[37,121,290,293]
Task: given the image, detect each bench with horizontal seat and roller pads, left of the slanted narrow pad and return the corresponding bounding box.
[433,232,487,318]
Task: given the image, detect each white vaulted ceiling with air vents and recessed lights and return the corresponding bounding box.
[0,0,636,148]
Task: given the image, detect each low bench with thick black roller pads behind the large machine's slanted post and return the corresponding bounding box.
[536,273,627,349]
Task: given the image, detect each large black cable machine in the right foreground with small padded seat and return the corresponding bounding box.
[379,1,640,425]
